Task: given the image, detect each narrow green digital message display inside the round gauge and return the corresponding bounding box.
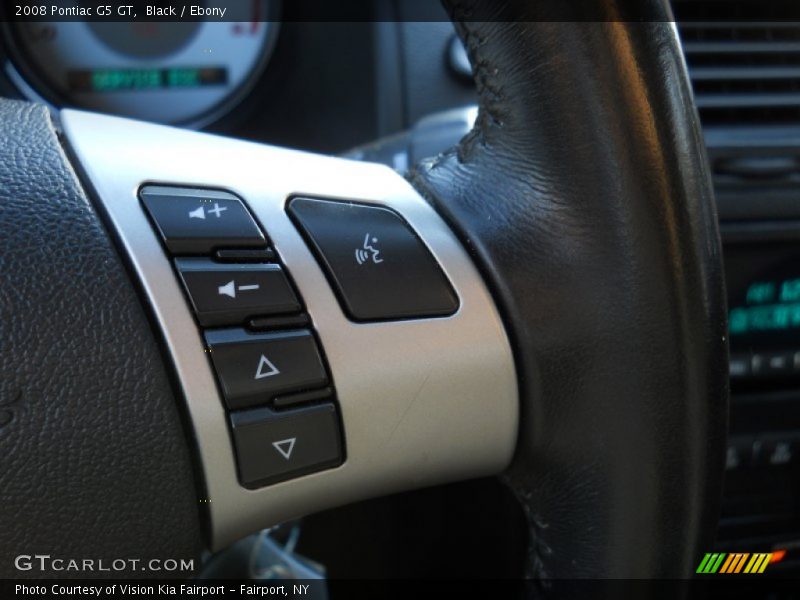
[67,67,228,92]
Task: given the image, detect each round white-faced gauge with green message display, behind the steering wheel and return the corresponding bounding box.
[7,0,278,126]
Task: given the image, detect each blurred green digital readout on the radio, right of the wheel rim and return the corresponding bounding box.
[728,278,800,336]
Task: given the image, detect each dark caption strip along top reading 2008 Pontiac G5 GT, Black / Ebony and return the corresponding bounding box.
[0,0,800,23]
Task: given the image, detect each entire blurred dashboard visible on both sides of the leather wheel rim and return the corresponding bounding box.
[0,0,800,573]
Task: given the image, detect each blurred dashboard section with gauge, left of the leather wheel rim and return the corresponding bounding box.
[0,6,475,153]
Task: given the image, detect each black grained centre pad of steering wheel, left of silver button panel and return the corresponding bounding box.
[0,100,205,578]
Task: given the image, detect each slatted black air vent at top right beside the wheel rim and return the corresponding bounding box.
[674,0,800,125]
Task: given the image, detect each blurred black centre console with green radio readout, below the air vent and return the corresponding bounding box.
[718,241,800,560]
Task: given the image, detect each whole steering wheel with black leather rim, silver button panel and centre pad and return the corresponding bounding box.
[0,0,727,584]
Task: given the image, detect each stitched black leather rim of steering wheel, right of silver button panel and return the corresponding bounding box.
[411,0,728,579]
